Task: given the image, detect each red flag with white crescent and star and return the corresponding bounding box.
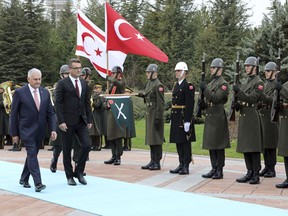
[105,2,168,62]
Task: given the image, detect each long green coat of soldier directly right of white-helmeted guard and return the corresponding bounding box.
[203,76,231,150]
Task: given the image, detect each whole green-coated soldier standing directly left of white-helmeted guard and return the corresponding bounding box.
[138,64,165,170]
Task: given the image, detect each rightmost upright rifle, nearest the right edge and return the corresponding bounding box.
[271,48,281,123]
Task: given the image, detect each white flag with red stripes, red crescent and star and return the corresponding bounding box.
[75,10,127,78]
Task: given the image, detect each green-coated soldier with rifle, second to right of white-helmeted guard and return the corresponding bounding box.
[233,56,264,184]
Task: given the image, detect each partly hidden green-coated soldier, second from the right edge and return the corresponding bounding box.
[259,62,278,178]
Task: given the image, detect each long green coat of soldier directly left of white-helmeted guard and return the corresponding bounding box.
[144,78,165,145]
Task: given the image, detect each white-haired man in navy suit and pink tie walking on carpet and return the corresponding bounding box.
[10,68,57,192]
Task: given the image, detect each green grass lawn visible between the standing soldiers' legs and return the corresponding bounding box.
[132,119,283,162]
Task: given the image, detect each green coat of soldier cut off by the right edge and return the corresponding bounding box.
[278,82,288,157]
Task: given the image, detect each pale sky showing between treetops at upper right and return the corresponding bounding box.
[195,0,285,27]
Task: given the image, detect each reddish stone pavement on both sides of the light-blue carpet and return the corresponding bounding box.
[0,146,288,216]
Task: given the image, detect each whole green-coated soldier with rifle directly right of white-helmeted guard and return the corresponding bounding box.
[200,58,231,179]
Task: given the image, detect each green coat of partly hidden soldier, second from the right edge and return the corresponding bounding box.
[259,80,278,149]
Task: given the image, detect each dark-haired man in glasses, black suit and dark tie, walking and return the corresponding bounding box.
[55,58,92,186]
